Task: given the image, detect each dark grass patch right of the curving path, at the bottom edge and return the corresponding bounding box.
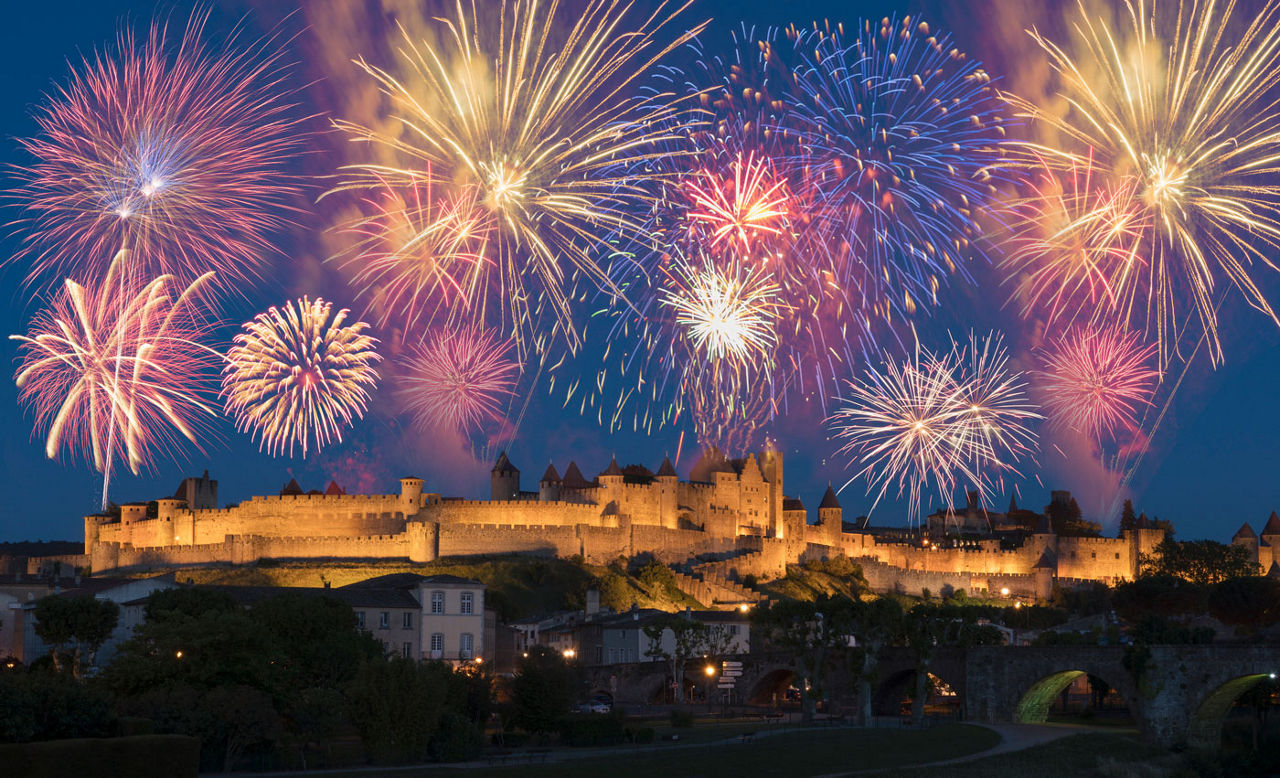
[893,732,1172,778]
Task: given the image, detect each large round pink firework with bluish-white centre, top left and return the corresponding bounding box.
[10,10,305,289]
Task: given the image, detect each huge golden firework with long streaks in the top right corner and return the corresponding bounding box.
[1009,0,1280,363]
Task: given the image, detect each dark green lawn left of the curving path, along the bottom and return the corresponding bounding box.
[302,724,1000,778]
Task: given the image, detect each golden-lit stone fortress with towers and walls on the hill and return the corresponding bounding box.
[74,452,1280,596]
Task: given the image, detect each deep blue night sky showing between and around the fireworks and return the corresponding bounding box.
[0,0,1280,540]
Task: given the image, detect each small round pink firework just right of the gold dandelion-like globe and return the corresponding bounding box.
[399,328,520,433]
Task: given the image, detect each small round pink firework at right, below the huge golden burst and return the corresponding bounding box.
[1037,326,1160,439]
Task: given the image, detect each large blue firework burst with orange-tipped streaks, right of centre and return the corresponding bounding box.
[788,18,1006,320]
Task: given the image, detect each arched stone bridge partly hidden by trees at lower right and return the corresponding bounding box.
[589,644,1280,747]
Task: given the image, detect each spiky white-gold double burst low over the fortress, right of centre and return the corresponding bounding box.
[831,337,1039,517]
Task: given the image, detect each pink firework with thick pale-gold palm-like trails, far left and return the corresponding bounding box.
[10,251,220,509]
